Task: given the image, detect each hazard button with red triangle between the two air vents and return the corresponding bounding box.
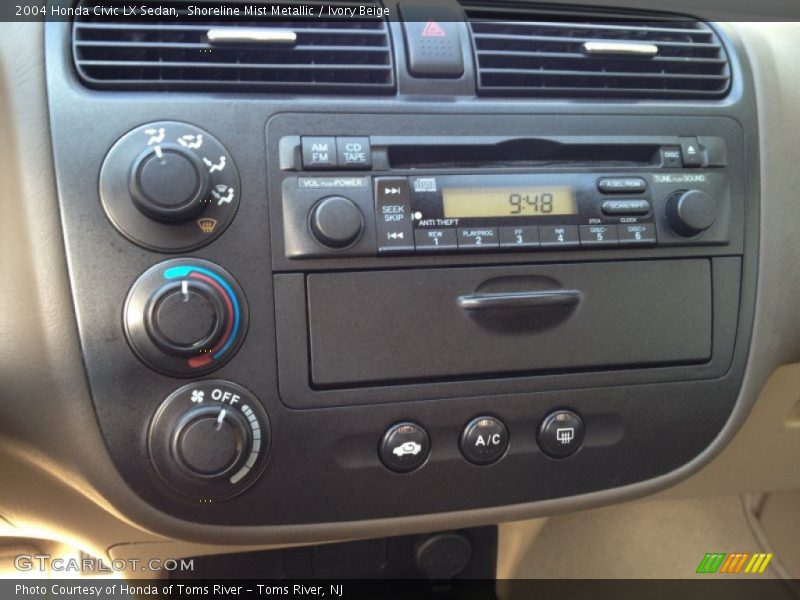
[400,2,464,79]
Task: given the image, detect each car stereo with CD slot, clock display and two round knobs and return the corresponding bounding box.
[281,136,730,258]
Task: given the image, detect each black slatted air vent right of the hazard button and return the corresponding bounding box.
[464,2,731,99]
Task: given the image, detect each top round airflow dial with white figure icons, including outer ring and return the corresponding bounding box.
[100,121,241,252]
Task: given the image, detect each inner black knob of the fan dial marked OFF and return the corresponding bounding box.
[172,405,252,480]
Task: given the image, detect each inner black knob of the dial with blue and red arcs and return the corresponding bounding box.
[145,278,226,356]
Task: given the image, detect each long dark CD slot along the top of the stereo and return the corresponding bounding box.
[386,138,660,169]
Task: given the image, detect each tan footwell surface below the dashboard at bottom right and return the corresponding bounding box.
[516,496,776,579]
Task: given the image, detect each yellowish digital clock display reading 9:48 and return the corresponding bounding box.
[442,186,578,219]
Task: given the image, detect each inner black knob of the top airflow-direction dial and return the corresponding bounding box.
[129,144,210,223]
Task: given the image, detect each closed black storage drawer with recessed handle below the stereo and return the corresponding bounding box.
[306,259,712,388]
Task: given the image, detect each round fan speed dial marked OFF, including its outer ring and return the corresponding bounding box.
[148,380,271,501]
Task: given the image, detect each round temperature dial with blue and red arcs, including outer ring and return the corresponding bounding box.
[124,259,248,377]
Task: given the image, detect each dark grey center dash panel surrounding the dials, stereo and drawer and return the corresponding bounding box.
[46,7,759,525]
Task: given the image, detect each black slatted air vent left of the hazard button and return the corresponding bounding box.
[72,0,394,95]
